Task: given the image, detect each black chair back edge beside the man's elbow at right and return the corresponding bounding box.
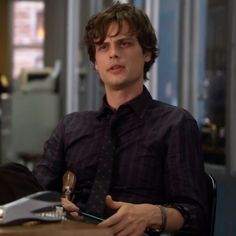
[205,173,217,236]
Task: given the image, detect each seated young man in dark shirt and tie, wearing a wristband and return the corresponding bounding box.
[34,3,206,236]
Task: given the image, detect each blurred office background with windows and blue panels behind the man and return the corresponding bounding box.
[0,0,236,236]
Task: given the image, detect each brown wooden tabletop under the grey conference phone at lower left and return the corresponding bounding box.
[0,220,113,236]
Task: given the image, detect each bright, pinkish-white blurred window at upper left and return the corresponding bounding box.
[12,1,45,79]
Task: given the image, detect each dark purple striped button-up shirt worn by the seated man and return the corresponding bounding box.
[33,87,206,236]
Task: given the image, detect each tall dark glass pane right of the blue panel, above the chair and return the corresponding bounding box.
[201,0,228,164]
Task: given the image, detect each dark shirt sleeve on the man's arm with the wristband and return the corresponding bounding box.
[165,116,207,236]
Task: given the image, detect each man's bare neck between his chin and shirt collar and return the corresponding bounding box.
[106,85,143,110]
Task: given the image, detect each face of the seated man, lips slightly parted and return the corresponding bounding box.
[95,21,151,91]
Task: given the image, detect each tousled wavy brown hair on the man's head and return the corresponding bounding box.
[84,2,160,80]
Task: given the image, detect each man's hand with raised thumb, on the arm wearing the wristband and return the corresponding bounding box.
[98,196,152,236]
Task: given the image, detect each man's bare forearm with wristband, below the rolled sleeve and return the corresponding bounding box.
[147,204,184,232]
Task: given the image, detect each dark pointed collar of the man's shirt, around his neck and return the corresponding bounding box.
[97,86,152,119]
